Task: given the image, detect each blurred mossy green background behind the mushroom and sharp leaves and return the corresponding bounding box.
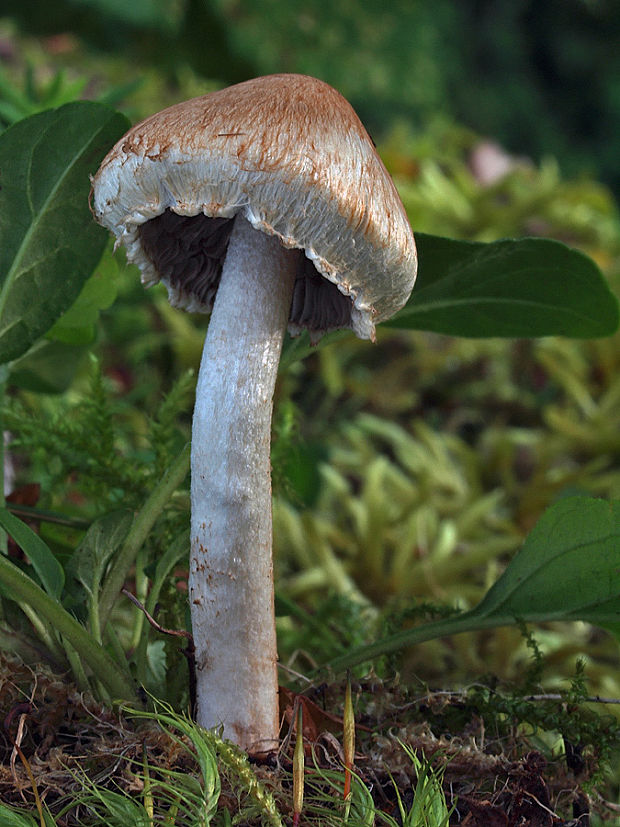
[0,0,620,695]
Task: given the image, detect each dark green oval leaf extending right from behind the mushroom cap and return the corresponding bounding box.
[384,233,618,338]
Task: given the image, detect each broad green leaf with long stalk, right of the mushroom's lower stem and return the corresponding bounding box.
[329,497,620,669]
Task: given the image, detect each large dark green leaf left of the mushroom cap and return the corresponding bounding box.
[0,101,128,364]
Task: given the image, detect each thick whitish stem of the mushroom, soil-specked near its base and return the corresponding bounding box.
[189,216,299,752]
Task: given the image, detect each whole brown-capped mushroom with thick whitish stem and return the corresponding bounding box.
[92,75,417,753]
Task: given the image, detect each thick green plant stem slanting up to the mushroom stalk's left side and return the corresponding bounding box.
[99,445,190,630]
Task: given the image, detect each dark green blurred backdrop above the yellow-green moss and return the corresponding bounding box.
[0,0,620,191]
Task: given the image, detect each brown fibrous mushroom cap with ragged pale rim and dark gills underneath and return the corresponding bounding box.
[92,74,417,338]
